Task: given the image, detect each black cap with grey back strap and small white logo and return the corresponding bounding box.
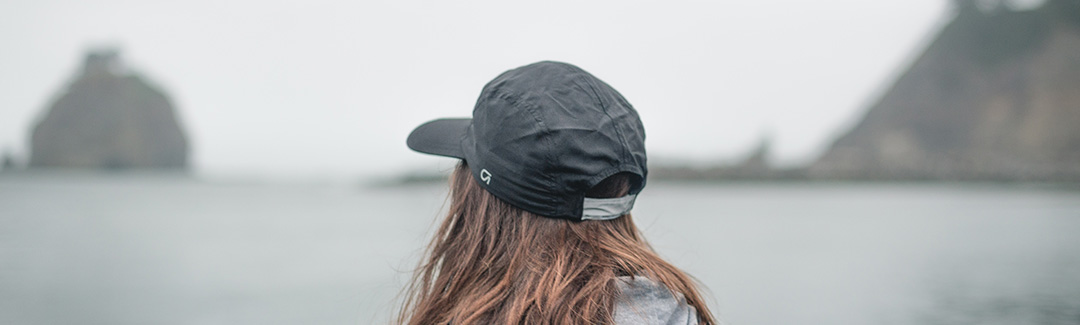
[407,62,648,220]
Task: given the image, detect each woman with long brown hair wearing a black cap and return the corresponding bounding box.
[399,62,715,324]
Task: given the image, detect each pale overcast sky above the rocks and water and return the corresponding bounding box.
[0,0,972,177]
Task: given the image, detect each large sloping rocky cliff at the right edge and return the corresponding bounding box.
[808,0,1080,180]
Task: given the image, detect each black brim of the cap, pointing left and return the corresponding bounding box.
[406,118,472,159]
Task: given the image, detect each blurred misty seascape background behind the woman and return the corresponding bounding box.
[0,0,1080,324]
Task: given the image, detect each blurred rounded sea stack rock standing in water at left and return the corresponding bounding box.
[29,50,189,170]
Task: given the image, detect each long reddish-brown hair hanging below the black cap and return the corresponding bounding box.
[397,161,715,325]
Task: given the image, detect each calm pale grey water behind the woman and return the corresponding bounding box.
[0,175,1080,324]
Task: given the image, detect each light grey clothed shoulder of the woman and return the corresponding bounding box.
[615,276,698,325]
